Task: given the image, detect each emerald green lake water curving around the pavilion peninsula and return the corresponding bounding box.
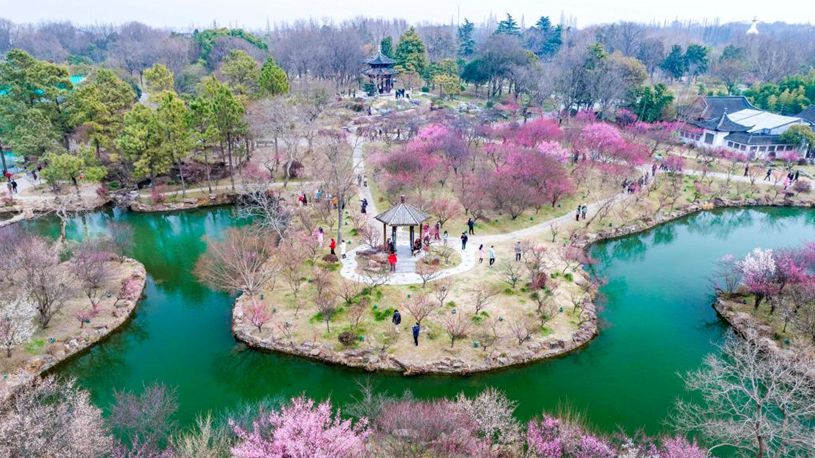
[28,208,815,433]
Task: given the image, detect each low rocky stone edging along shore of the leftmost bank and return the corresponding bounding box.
[0,258,147,402]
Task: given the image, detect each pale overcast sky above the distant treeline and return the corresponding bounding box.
[0,0,815,29]
